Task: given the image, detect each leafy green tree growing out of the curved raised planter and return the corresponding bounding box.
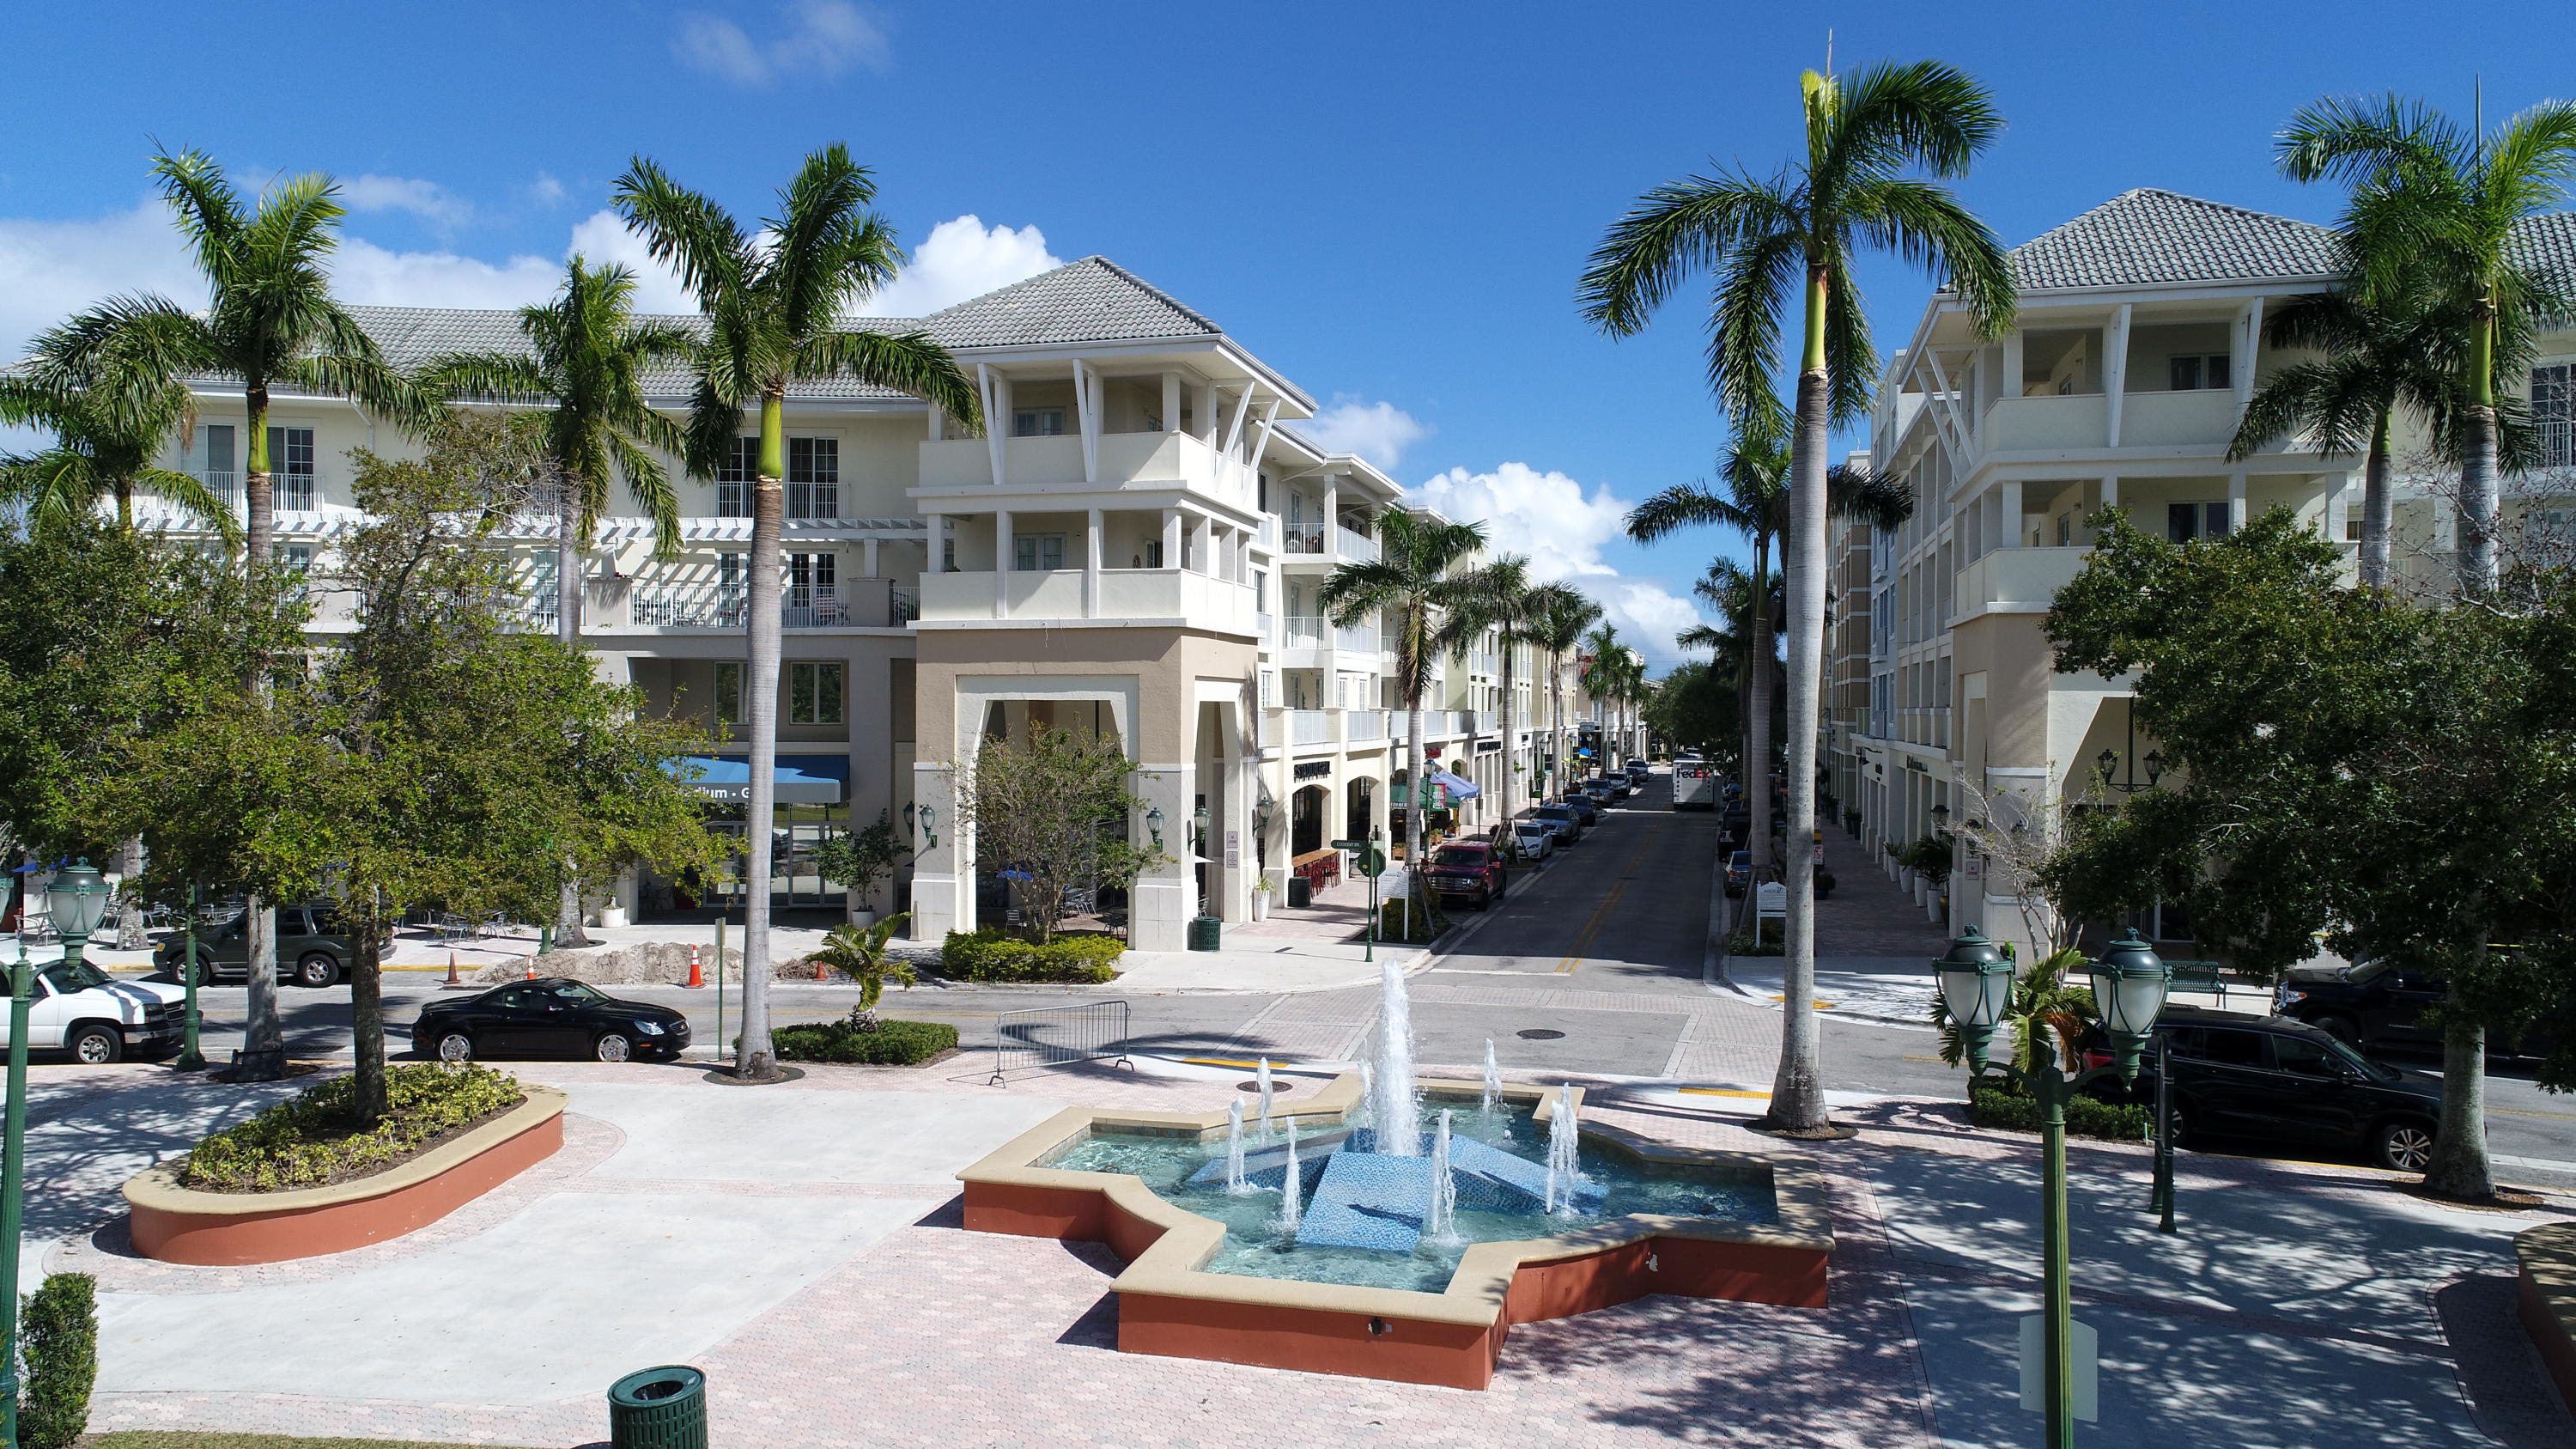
[121,420,714,1127]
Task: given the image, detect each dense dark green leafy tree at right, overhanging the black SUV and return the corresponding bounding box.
[2043,510,2576,1199]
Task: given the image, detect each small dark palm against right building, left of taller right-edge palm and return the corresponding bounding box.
[2228,278,2465,588]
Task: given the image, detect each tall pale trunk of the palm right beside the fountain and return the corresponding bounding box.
[1770,263,1832,1135]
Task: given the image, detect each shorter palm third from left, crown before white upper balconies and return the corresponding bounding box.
[422,255,693,947]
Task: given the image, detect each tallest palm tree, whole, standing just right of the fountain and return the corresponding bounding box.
[1582,62,2012,1132]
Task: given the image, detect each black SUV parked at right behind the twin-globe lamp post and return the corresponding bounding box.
[2087,1006,2442,1173]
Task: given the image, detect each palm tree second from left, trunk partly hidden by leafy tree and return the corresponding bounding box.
[52,149,443,1060]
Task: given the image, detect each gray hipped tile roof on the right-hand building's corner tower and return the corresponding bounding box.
[2012,188,2339,291]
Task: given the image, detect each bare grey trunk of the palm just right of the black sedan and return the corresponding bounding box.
[734,392,788,1078]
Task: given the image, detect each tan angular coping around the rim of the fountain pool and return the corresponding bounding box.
[958,1073,1834,1328]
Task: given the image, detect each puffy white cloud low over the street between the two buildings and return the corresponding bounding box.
[1406,461,1703,667]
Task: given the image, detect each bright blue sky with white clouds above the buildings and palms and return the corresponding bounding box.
[0,0,2576,673]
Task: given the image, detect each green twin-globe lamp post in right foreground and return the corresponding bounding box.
[1932,926,2172,1449]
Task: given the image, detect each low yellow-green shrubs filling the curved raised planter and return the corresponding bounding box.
[178,1062,528,1191]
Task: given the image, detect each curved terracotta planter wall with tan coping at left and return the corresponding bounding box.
[126,1083,567,1266]
